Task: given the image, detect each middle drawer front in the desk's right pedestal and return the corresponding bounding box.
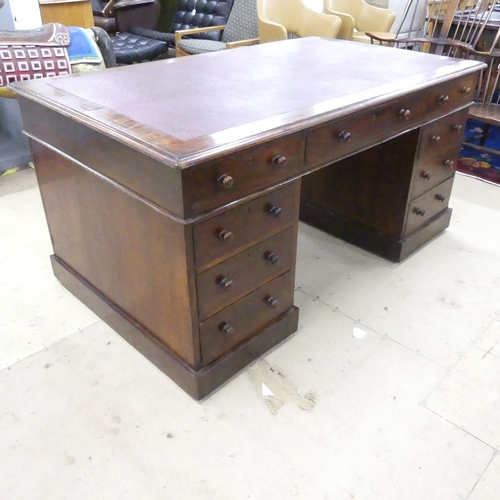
[410,143,461,200]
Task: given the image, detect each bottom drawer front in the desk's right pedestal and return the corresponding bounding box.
[405,177,453,234]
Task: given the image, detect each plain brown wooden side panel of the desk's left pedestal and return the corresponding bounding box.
[32,141,199,367]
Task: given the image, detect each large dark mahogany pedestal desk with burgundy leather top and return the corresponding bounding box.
[13,38,482,399]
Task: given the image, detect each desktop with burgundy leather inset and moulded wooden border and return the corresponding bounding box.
[9,37,480,168]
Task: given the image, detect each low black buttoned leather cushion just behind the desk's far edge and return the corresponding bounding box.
[111,32,168,64]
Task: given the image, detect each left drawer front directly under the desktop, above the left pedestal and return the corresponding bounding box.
[183,134,305,217]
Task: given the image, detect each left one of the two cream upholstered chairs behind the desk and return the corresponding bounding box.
[257,0,342,43]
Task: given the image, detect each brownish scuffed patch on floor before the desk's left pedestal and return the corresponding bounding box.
[248,360,317,414]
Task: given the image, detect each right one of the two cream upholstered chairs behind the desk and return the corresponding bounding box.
[324,0,396,43]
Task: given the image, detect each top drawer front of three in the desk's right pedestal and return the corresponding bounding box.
[417,108,469,159]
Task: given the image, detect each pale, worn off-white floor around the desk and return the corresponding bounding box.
[0,170,500,500]
